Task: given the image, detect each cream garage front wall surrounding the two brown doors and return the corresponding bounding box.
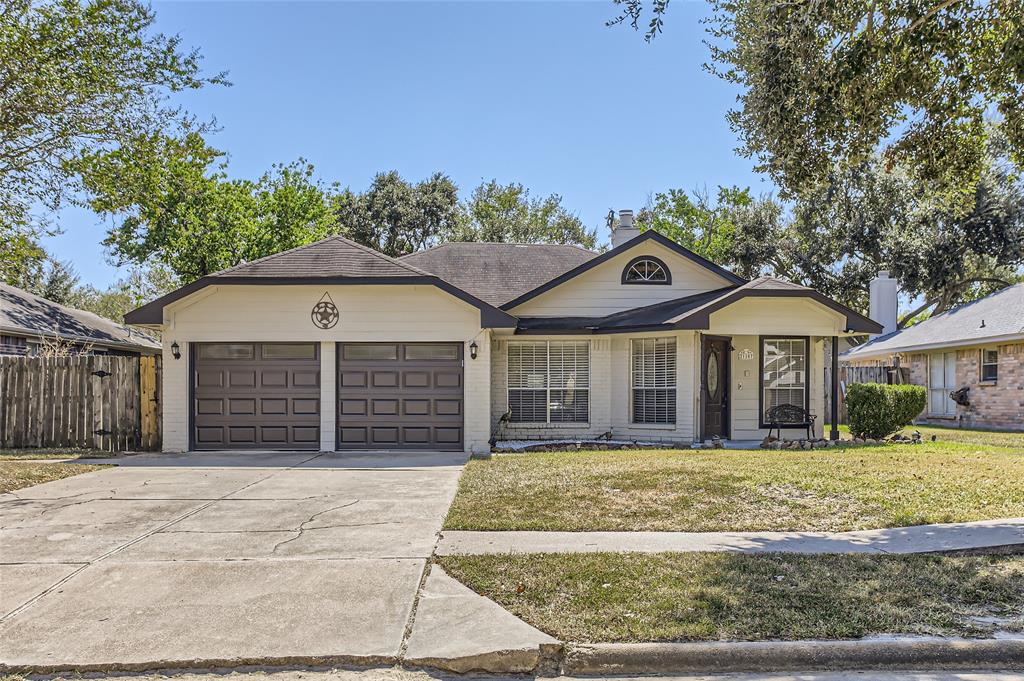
[163,285,490,452]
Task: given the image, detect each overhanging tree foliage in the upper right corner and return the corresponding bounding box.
[615,0,1024,201]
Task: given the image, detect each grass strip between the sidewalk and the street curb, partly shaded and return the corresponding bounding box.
[437,553,1024,642]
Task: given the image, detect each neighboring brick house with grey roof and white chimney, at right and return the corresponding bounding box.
[842,280,1024,430]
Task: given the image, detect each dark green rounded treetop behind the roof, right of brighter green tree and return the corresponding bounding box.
[338,170,460,256]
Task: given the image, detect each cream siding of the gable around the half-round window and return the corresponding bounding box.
[511,241,730,316]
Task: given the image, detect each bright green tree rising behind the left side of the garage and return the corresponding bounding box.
[81,132,339,284]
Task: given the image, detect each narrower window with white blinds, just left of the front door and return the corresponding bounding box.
[631,338,676,423]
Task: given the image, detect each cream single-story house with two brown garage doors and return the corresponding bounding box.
[125,211,881,453]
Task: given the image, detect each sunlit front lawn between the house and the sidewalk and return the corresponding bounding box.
[445,441,1024,531]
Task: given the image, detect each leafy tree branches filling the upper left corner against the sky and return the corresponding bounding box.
[0,0,225,231]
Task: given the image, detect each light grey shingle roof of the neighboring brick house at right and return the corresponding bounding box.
[843,284,1024,359]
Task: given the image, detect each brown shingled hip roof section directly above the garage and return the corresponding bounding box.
[211,236,427,278]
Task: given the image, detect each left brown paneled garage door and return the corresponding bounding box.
[193,343,319,450]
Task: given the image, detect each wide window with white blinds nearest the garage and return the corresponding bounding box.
[508,341,590,423]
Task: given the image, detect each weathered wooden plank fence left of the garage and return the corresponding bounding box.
[0,355,161,452]
